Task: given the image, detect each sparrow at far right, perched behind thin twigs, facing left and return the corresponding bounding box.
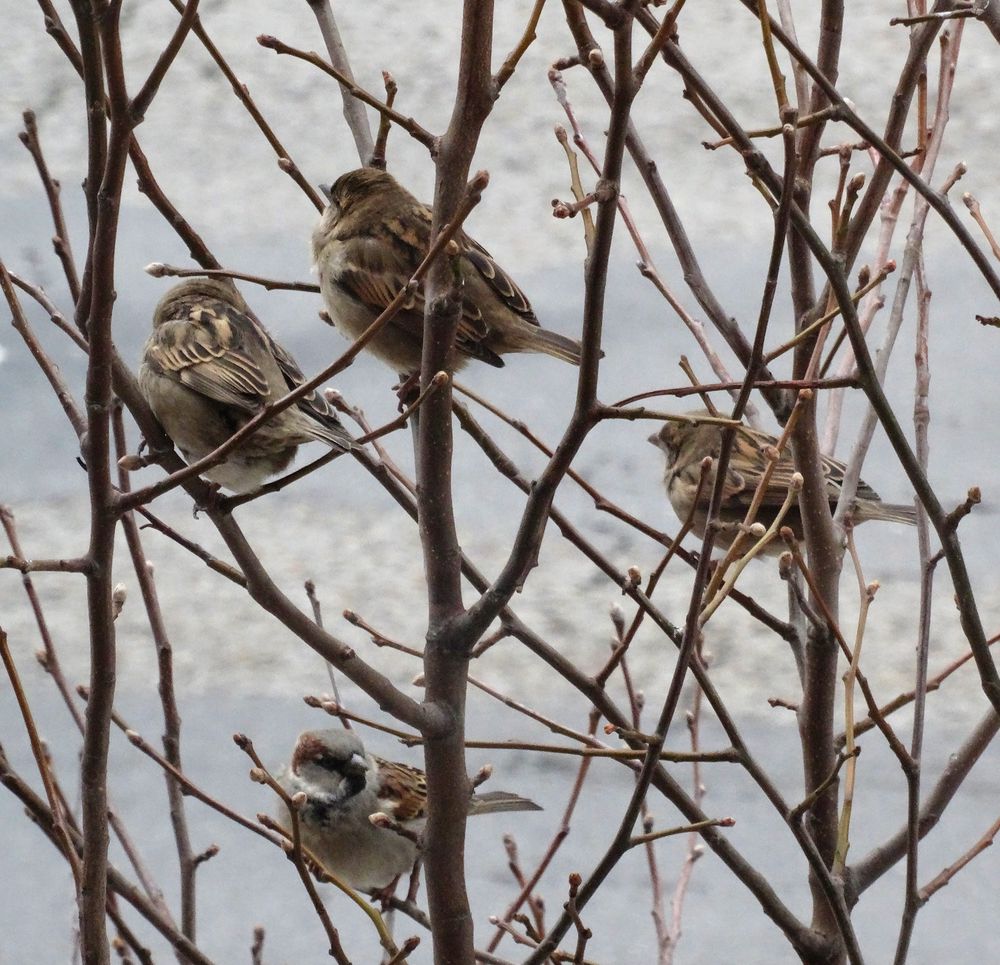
[649,410,917,555]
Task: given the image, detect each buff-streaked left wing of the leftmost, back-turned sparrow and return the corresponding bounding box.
[146,297,272,411]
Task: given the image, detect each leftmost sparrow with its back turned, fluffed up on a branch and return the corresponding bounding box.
[139,278,354,493]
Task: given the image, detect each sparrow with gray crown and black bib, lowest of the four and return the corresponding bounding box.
[277,729,541,891]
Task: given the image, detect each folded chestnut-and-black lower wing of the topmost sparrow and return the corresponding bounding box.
[337,206,508,365]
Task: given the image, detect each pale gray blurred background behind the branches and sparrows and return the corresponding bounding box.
[0,0,1000,963]
